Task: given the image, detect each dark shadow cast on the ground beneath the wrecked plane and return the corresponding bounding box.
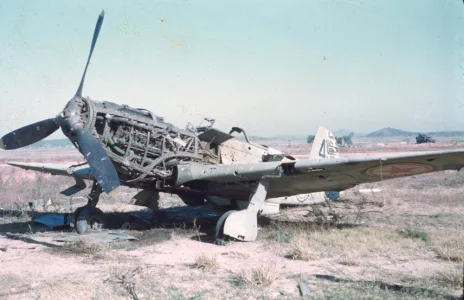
[0,205,366,247]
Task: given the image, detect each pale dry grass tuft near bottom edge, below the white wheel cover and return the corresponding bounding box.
[238,261,279,287]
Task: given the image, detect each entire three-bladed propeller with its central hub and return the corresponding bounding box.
[0,11,119,195]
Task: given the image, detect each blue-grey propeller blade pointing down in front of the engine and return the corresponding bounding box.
[76,127,119,194]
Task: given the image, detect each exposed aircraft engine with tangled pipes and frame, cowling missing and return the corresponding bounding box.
[84,99,208,188]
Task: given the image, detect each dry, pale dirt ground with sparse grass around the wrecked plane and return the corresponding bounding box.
[0,141,464,299]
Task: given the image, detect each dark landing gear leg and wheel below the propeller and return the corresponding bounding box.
[73,181,105,234]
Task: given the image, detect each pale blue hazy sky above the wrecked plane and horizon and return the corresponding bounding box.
[0,0,464,137]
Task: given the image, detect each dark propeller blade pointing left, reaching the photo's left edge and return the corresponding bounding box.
[0,118,60,150]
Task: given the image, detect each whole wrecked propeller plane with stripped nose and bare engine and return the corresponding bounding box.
[0,11,464,244]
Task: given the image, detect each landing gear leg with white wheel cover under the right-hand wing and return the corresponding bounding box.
[215,178,269,245]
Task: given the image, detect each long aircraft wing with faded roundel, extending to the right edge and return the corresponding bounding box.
[177,150,464,198]
